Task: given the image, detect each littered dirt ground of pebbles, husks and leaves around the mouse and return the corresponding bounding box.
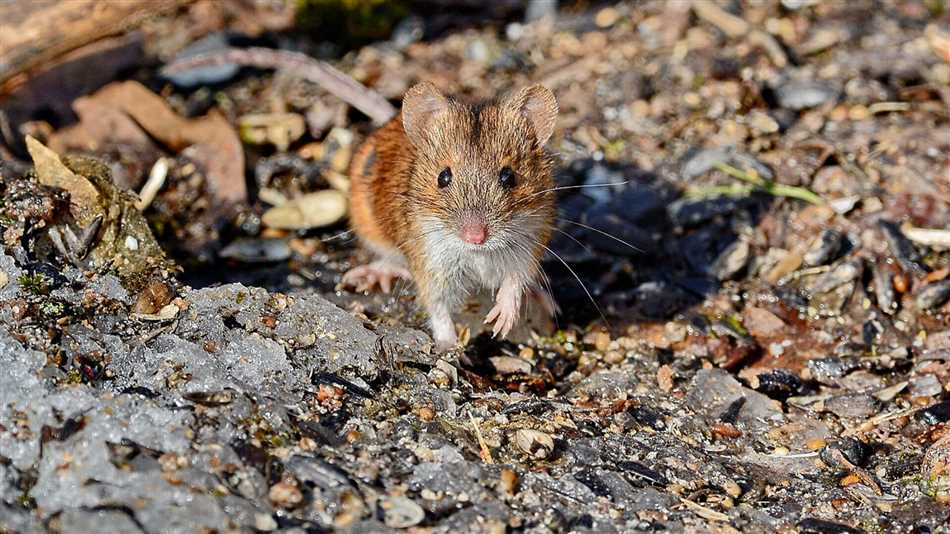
[0,0,950,533]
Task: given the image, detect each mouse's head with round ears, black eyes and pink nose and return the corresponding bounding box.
[402,82,558,255]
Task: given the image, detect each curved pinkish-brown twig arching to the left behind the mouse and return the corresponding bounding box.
[162,47,396,124]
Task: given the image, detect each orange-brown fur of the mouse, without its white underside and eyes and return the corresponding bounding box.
[350,84,557,318]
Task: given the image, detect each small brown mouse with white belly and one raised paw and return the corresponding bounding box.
[343,82,558,350]
